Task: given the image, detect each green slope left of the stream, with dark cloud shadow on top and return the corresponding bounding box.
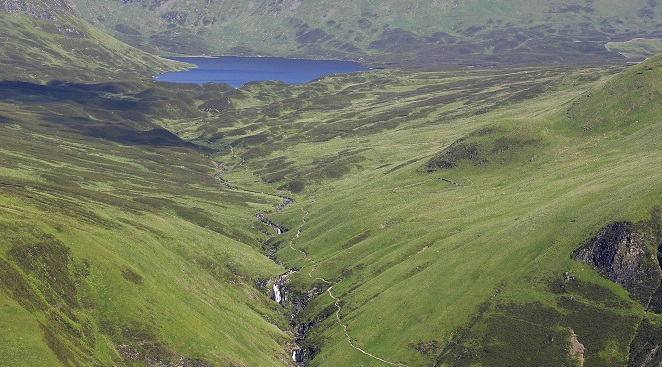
[0,82,291,366]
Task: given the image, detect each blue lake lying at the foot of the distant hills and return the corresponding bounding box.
[156,56,369,88]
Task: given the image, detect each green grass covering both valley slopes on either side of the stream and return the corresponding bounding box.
[0,61,661,365]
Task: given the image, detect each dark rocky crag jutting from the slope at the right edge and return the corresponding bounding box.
[572,222,662,307]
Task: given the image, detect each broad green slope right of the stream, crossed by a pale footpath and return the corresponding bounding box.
[166,57,662,366]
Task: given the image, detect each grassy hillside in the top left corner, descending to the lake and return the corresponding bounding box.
[0,0,184,82]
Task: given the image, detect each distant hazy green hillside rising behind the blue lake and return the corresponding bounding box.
[68,0,662,68]
